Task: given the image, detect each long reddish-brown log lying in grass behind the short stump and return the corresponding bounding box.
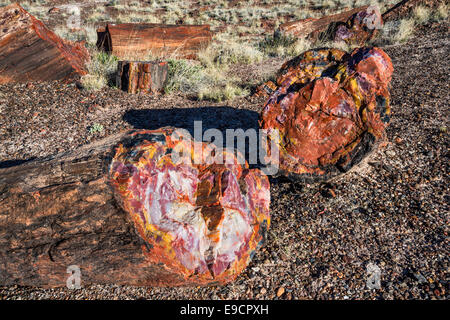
[97,23,212,60]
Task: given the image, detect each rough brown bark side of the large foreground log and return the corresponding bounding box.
[0,133,192,287]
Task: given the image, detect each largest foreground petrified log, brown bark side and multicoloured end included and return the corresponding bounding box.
[0,130,270,287]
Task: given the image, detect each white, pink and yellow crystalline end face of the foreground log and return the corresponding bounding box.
[110,128,270,284]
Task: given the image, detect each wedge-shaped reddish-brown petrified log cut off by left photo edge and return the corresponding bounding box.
[0,4,89,84]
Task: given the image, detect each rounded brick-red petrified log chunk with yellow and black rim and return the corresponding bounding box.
[260,47,393,181]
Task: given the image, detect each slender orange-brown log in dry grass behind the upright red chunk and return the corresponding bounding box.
[280,6,368,39]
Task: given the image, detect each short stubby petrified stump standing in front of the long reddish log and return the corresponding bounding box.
[116,61,169,94]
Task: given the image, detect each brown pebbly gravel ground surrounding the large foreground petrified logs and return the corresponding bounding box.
[0,25,450,299]
